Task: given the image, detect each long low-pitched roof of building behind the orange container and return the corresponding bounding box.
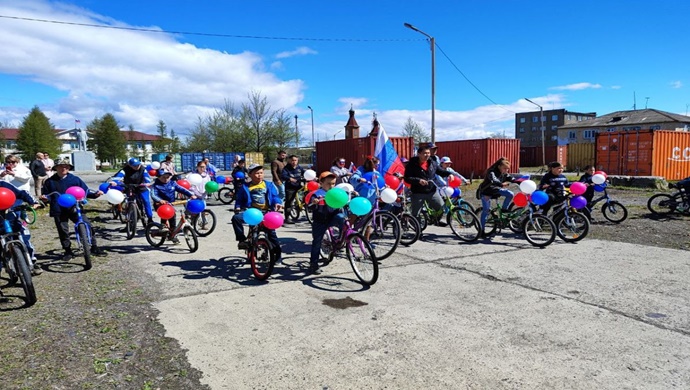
[558,108,690,130]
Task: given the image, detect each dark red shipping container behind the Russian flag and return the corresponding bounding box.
[315,137,414,172]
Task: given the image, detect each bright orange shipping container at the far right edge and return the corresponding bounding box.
[596,130,690,180]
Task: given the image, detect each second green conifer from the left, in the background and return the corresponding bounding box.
[86,114,127,166]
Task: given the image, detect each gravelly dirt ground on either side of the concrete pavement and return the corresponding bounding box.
[0,188,690,389]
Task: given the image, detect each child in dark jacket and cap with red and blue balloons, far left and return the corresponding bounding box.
[41,159,105,261]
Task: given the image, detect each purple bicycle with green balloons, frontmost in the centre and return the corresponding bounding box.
[320,215,379,286]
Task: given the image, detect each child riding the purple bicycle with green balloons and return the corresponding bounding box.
[309,172,345,275]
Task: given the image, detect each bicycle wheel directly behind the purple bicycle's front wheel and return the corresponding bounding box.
[359,211,402,261]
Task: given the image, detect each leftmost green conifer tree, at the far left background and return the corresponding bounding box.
[17,106,62,161]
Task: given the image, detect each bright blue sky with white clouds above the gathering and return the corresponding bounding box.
[0,0,690,145]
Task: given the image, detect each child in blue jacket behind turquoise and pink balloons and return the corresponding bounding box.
[232,164,283,262]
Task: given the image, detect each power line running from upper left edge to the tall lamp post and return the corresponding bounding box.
[0,15,423,42]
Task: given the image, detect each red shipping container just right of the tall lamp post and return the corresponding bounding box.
[436,138,520,179]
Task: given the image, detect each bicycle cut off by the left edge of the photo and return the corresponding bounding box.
[0,205,37,307]
